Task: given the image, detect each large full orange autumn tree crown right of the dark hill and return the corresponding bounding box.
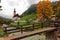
[37,0,54,18]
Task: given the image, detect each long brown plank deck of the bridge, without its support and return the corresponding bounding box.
[0,27,56,40]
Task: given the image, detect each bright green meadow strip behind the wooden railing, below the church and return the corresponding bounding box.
[10,22,47,29]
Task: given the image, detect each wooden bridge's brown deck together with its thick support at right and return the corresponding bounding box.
[0,27,58,40]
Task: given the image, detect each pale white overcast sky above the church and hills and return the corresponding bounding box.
[0,0,58,18]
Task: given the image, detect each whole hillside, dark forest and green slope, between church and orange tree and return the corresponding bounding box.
[21,4,36,20]
